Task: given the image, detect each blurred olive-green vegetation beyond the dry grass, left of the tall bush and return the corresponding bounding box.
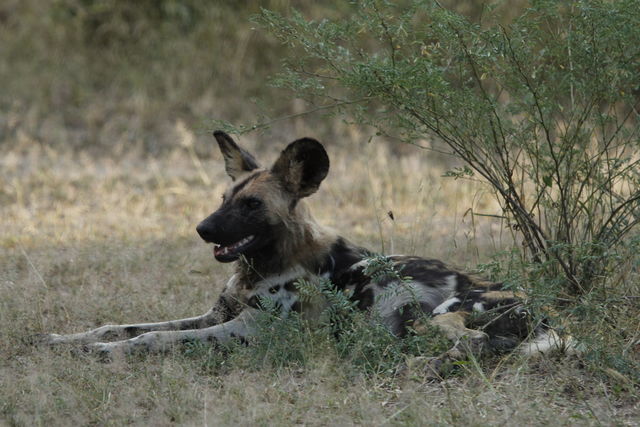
[0,0,526,156]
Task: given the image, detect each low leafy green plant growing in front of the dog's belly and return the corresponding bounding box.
[184,281,452,379]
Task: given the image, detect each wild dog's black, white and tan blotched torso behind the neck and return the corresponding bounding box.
[318,237,531,349]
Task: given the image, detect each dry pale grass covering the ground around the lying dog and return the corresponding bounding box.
[0,130,638,425]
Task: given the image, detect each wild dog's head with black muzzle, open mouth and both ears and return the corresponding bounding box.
[196,131,329,262]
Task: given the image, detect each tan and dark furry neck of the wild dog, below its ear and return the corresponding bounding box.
[237,201,335,281]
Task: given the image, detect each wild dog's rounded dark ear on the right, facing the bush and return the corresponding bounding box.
[271,138,329,198]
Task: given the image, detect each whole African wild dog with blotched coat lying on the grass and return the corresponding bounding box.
[45,131,568,362]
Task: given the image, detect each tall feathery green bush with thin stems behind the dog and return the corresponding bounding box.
[257,0,640,382]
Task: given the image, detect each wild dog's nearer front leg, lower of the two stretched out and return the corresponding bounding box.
[86,308,257,357]
